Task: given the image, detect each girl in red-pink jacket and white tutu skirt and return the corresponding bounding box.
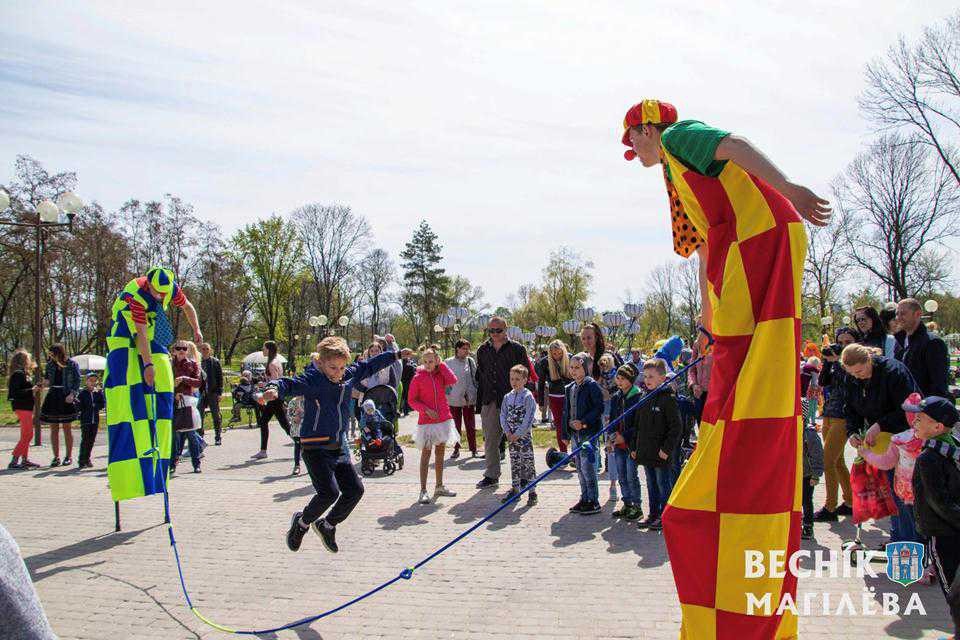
[407,345,460,504]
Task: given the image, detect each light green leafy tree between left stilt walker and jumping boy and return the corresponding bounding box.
[233,215,301,340]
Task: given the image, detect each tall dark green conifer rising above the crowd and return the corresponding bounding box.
[400,220,450,344]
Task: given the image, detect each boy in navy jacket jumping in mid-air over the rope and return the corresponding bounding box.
[259,336,397,553]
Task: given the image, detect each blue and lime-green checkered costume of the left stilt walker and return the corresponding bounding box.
[104,278,179,501]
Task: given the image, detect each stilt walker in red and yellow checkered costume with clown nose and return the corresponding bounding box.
[623,100,829,640]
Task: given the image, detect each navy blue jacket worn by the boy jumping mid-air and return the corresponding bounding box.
[266,351,399,449]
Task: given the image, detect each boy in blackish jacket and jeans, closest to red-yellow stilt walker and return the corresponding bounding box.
[630,358,683,531]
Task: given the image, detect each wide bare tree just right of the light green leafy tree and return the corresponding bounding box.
[291,204,370,318]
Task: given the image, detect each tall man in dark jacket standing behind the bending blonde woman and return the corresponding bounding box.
[894,298,950,398]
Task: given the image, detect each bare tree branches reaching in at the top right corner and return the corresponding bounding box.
[859,13,960,184]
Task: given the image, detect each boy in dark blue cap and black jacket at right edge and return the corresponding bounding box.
[904,396,960,637]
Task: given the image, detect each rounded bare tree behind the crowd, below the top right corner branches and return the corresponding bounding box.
[833,135,960,297]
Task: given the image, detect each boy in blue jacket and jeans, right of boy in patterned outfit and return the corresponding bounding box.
[562,353,603,515]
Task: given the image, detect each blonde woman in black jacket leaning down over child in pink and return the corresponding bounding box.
[840,344,917,448]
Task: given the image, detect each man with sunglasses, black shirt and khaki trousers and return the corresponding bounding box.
[477,316,530,489]
